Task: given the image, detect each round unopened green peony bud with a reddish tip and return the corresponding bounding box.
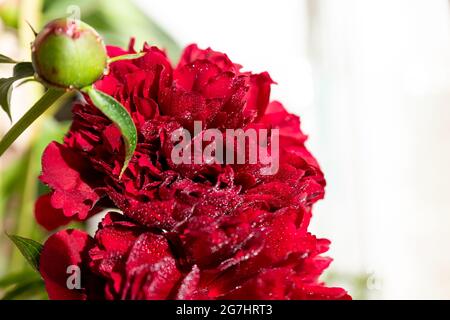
[31,18,108,89]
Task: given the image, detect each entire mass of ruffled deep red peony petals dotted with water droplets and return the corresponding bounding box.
[36,40,350,299]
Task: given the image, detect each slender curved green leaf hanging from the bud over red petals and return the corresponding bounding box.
[82,86,137,178]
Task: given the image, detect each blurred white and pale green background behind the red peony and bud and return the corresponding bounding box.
[0,0,450,299]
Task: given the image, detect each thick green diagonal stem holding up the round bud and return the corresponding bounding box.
[0,89,65,156]
